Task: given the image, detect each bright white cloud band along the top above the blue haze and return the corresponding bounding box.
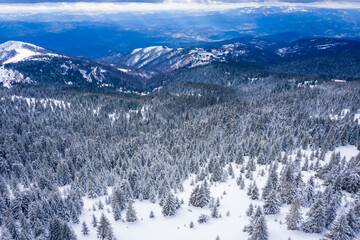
[0,0,360,14]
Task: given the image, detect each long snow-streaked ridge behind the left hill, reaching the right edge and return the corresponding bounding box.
[101,38,360,72]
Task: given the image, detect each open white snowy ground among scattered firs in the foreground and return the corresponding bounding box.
[73,146,359,240]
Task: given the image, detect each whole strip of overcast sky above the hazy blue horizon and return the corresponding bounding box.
[0,0,360,13]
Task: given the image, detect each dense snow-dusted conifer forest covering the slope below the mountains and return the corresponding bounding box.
[0,78,360,240]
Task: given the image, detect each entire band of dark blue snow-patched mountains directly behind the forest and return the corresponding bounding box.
[0,38,360,93]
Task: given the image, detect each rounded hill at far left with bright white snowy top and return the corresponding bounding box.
[0,41,145,90]
